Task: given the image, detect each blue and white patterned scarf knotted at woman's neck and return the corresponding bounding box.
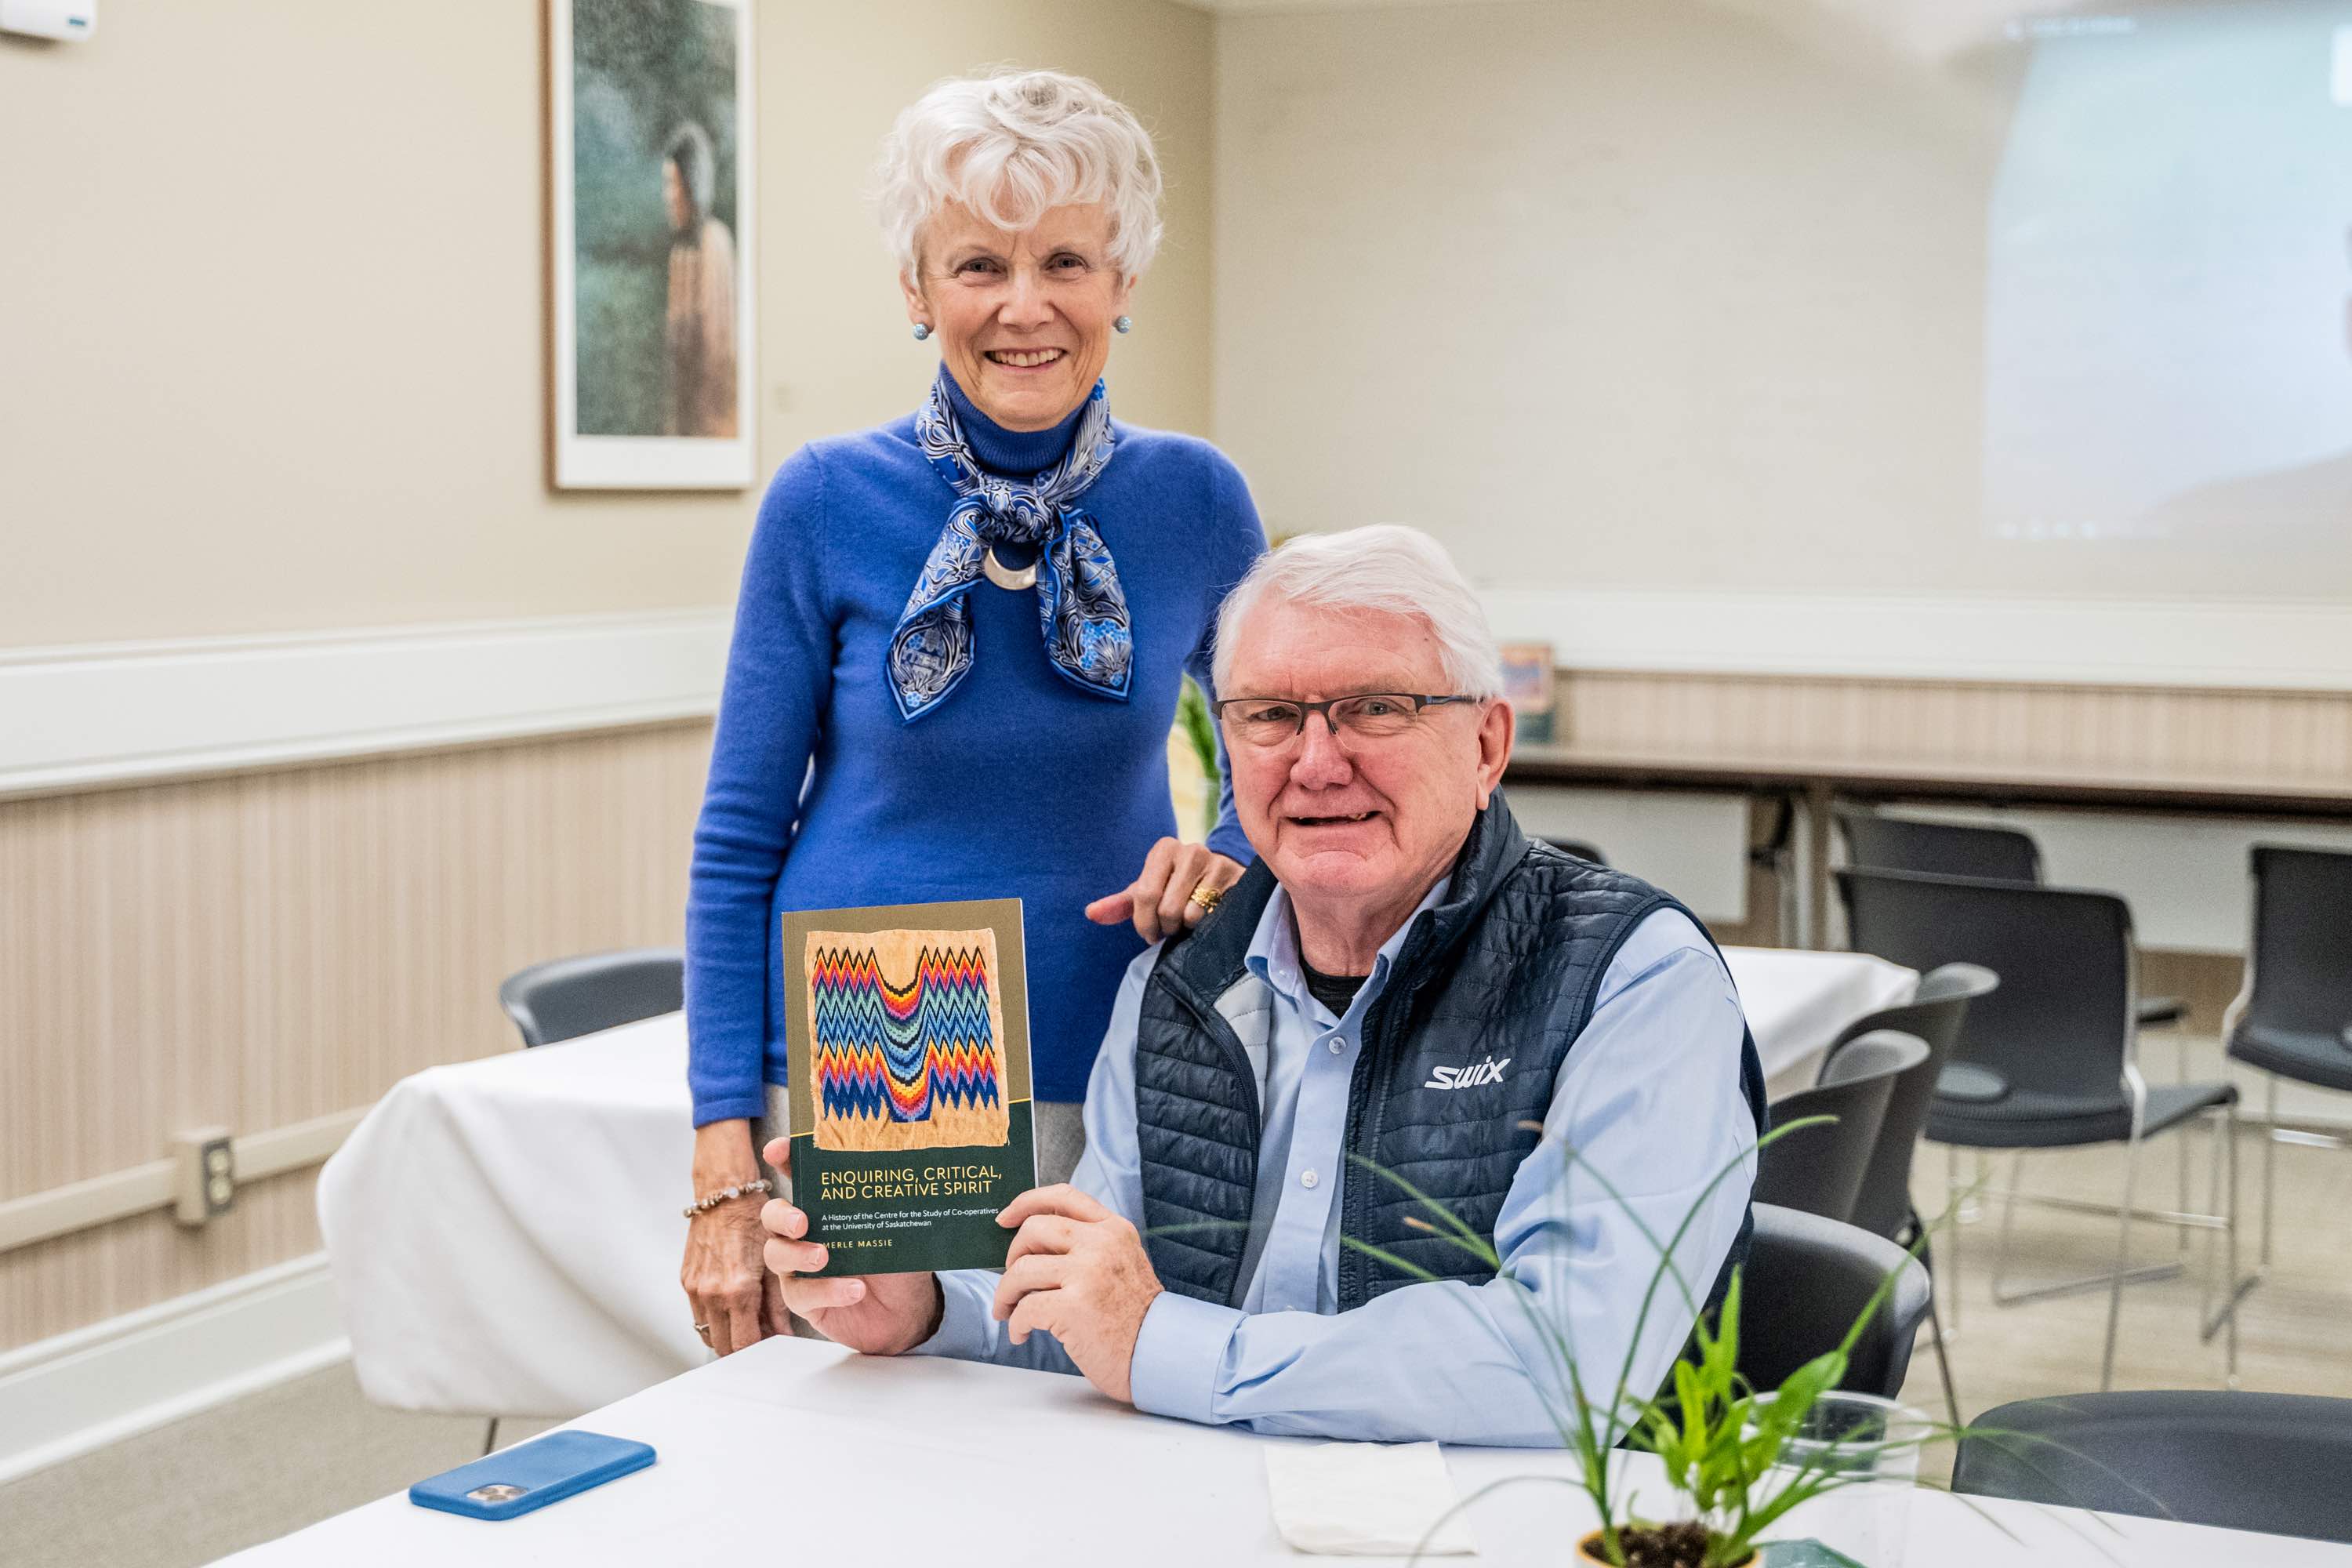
[887,367,1136,724]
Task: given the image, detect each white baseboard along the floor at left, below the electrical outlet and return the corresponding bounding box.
[0,1253,350,1483]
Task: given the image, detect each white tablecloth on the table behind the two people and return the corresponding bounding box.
[318,947,1917,1415]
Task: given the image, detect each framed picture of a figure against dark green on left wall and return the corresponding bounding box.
[548,0,757,489]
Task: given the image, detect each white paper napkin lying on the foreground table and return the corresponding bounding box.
[1265,1443,1477,1556]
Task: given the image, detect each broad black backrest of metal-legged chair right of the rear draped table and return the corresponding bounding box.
[1837,867,2138,1105]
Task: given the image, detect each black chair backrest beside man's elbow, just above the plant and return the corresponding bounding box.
[1738,1203,1929,1399]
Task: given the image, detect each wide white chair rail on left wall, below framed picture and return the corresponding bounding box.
[0,609,729,797]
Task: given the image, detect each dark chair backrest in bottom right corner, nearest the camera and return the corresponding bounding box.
[1952,1389,2352,1542]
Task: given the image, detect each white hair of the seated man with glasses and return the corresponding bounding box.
[1209,522,1503,699]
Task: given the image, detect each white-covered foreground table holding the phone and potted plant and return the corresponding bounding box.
[212,1340,2352,1568]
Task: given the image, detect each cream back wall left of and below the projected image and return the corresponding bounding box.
[1214,0,2352,602]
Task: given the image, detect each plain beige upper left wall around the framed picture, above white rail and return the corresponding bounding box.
[0,0,1211,647]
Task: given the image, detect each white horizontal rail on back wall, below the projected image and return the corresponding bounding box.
[1479,588,2352,691]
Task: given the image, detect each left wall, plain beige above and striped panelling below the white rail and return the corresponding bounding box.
[0,0,1211,1349]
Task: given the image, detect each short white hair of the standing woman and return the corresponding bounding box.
[877,71,1160,278]
